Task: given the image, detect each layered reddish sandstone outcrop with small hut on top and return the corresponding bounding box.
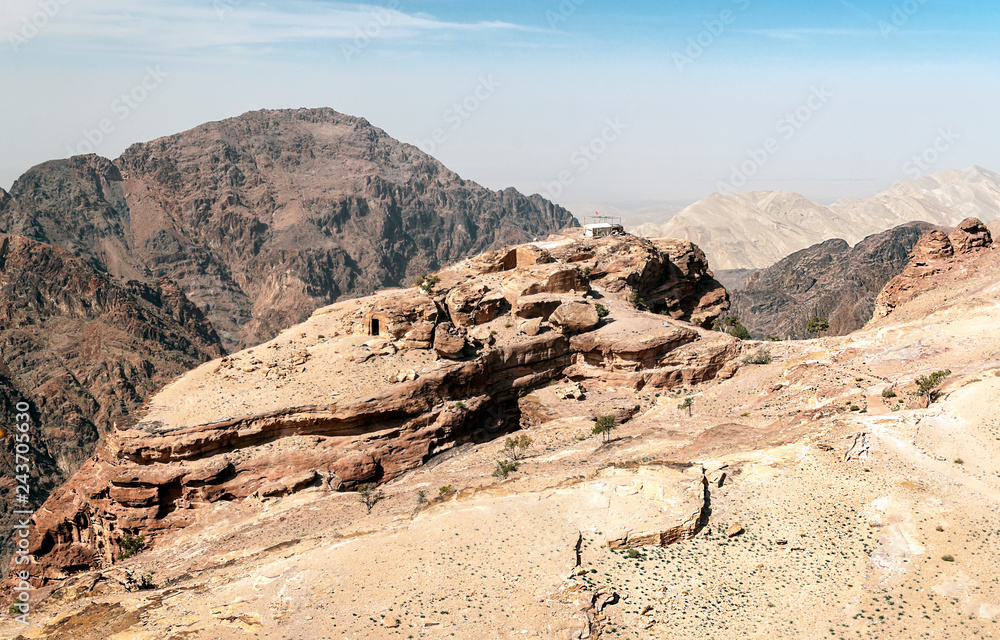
[11,234,740,580]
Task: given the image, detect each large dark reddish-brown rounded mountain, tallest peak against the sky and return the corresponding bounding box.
[0,109,576,350]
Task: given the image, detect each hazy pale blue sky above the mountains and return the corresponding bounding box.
[0,0,1000,207]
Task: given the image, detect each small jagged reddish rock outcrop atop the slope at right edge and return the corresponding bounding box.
[874,218,993,319]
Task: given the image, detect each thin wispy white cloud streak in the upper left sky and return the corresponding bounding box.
[0,0,541,53]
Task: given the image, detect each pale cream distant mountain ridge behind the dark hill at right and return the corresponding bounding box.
[635,167,1000,270]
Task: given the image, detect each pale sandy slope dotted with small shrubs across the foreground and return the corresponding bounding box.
[0,231,1000,640]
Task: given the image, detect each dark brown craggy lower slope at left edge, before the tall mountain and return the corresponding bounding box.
[0,236,222,576]
